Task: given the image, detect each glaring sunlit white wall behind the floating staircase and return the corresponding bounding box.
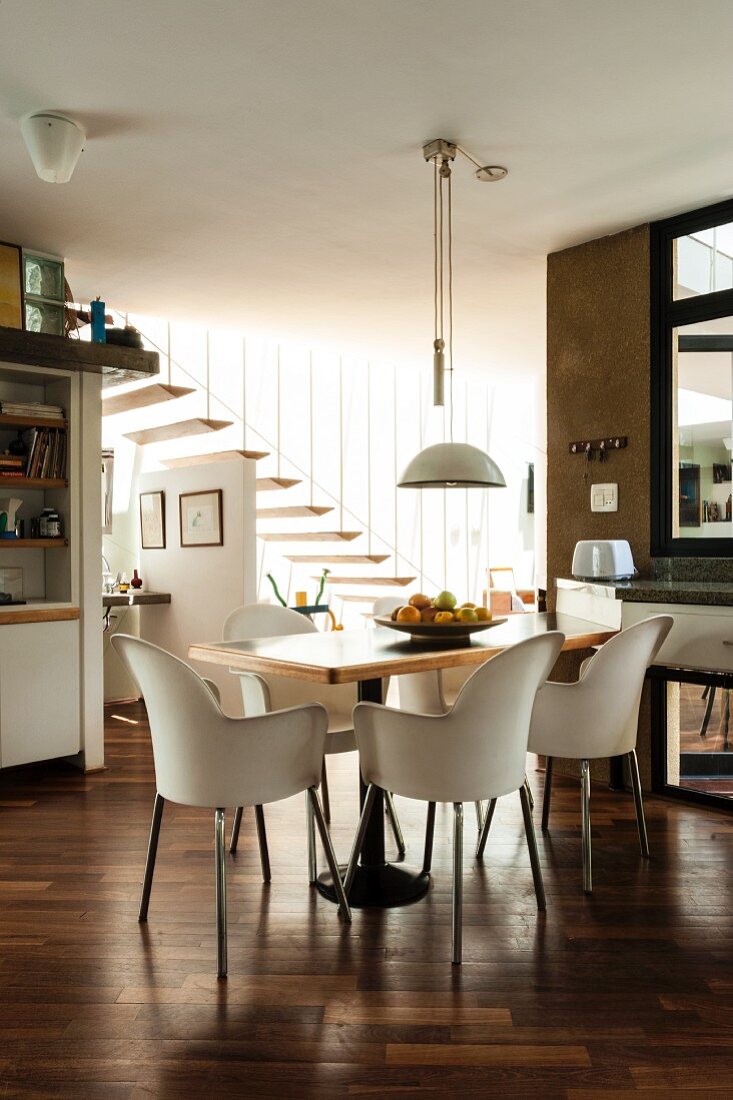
[105,316,544,625]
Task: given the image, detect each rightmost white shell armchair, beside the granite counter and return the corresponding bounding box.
[526,615,674,893]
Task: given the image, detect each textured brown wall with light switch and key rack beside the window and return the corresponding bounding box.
[547,226,649,594]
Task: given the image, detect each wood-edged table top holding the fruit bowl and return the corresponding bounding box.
[188,613,617,684]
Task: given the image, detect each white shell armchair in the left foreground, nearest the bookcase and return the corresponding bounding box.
[112,634,351,978]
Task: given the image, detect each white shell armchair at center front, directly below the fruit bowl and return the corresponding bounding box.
[343,631,565,964]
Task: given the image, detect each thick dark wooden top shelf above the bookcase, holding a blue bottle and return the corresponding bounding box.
[0,327,160,385]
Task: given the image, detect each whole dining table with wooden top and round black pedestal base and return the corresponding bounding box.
[188,613,617,908]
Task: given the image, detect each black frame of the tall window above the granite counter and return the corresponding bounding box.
[649,199,733,558]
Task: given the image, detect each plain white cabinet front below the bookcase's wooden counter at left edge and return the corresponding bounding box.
[0,619,81,768]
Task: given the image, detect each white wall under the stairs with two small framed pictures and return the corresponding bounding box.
[136,461,255,714]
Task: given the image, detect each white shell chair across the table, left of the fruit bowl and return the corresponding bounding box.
[222,604,405,882]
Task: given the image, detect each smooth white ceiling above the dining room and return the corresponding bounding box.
[0,0,733,372]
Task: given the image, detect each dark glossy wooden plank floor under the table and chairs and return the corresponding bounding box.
[0,706,733,1100]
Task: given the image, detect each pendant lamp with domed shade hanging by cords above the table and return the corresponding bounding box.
[397,138,507,488]
